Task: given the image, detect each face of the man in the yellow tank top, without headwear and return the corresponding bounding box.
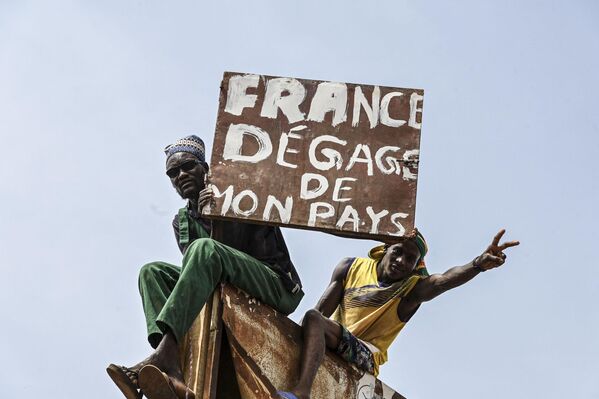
[379,240,420,282]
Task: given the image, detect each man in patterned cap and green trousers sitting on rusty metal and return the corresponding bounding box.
[107,135,304,399]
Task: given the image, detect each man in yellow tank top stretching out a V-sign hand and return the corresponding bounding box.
[278,229,519,399]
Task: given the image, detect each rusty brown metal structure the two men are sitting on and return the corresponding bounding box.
[181,285,405,399]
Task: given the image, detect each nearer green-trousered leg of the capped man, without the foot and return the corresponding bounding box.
[157,238,303,341]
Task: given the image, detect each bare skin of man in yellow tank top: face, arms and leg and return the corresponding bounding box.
[291,229,520,399]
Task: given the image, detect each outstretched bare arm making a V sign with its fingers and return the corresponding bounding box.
[410,229,520,304]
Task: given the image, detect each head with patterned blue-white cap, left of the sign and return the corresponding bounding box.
[164,135,208,200]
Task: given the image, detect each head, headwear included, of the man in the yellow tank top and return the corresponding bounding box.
[378,229,428,283]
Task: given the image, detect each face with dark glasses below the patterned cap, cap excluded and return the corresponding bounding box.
[166,152,206,200]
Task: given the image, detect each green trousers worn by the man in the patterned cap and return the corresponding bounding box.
[139,238,304,348]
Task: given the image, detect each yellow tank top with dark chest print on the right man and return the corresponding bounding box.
[332,258,422,376]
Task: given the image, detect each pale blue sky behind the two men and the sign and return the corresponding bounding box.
[0,0,599,399]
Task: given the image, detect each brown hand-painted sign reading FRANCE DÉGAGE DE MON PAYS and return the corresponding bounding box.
[203,72,423,239]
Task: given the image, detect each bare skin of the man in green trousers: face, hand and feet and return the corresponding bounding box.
[115,152,212,397]
